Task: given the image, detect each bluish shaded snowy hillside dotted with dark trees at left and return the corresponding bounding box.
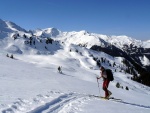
[0,33,61,54]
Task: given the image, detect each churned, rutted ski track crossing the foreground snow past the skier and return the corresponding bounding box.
[0,91,150,113]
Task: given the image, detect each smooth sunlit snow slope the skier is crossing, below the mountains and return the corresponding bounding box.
[0,46,150,113]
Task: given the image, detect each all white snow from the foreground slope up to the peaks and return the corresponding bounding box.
[0,20,150,113]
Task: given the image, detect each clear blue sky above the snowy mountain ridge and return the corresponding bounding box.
[0,0,150,40]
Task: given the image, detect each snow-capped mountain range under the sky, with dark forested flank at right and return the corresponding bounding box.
[0,19,150,85]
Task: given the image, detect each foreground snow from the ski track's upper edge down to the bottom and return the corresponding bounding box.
[2,91,150,113]
